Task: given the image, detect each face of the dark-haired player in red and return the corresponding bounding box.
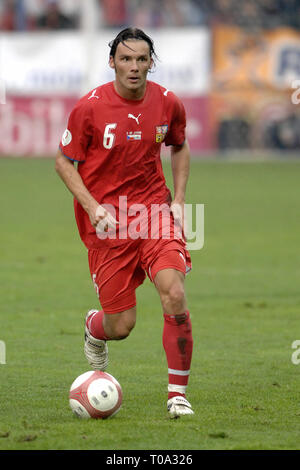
[109,39,153,99]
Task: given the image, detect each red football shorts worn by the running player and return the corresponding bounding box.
[88,238,191,313]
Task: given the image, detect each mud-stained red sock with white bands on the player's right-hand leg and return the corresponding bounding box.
[163,311,193,399]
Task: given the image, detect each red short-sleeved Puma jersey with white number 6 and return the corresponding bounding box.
[60,81,186,248]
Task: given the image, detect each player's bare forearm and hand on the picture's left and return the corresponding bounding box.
[55,149,107,227]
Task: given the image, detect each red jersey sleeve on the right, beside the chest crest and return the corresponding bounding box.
[164,94,186,146]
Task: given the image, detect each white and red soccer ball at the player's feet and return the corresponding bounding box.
[69,370,123,419]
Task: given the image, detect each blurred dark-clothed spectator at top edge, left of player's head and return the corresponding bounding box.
[36,0,77,30]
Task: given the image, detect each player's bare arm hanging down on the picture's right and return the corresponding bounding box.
[171,140,190,225]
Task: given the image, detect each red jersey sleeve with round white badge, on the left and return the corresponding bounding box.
[59,101,93,162]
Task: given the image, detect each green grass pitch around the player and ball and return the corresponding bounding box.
[0,158,300,450]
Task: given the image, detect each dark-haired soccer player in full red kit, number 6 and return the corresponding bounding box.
[56,28,194,418]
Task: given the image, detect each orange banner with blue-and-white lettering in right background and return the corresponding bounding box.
[213,26,300,92]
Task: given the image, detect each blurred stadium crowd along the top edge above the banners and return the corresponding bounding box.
[0,0,300,31]
